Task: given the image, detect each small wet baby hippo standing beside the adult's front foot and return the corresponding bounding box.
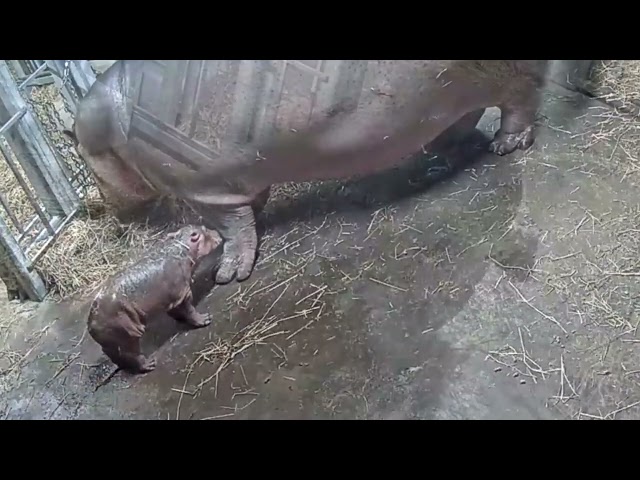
[88,225,222,373]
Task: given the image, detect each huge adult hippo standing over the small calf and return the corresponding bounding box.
[69,60,548,283]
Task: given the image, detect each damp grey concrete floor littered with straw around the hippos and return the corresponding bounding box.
[0,75,640,419]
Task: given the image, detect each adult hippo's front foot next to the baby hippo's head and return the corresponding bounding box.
[216,206,258,284]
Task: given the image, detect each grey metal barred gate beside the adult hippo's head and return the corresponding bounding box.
[0,60,95,301]
